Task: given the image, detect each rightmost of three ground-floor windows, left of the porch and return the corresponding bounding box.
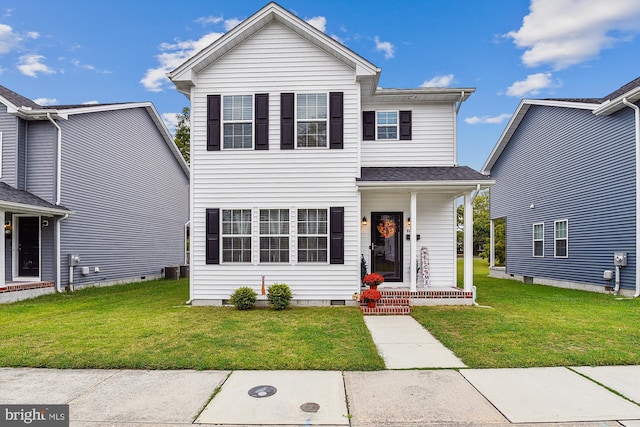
[298,209,328,262]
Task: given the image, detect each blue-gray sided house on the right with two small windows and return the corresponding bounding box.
[483,78,640,297]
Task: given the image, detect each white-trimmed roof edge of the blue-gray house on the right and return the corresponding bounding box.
[482,77,640,174]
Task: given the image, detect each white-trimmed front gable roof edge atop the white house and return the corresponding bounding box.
[167,2,380,97]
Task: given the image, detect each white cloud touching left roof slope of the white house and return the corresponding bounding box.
[140,32,223,92]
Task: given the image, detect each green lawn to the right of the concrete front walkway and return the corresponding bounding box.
[413,259,640,368]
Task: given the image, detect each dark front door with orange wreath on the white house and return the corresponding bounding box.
[371,212,402,282]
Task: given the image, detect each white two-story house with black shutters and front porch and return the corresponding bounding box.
[169,3,492,305]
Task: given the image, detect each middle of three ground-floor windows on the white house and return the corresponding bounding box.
[260,209,289,262]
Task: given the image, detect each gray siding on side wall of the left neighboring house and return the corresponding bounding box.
[58,108,189,285]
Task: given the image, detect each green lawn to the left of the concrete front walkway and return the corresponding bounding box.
[0,280,384,370]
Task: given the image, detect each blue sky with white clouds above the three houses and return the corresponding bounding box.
[0,0,640,170]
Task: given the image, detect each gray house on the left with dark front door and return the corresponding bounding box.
[0,86,189,302]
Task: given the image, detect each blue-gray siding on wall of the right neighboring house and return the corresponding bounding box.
[491,105,637,288]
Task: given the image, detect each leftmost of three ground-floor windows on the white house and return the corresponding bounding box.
[222,209,251,262]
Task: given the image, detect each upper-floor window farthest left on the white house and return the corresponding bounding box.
[222,95,253,148]
